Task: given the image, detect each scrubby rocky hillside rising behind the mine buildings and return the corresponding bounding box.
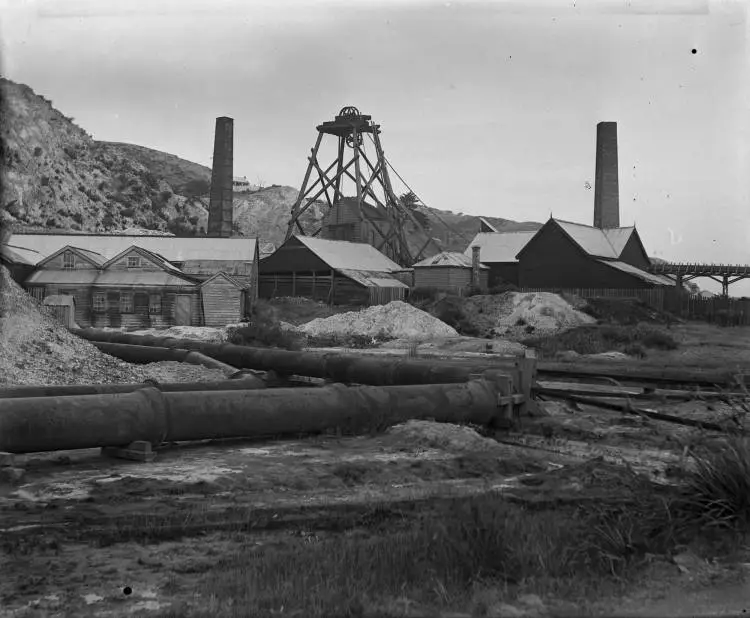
[0,78,540,252]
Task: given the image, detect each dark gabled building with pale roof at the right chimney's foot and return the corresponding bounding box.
[516,218,674,289]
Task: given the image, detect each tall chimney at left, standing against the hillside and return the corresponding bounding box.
[208,116,234,238]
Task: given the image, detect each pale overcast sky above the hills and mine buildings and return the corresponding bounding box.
[0,0,750,295]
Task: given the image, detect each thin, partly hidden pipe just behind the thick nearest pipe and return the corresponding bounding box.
[0,375,267,399]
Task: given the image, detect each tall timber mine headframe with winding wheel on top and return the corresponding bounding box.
[286,107,434,267]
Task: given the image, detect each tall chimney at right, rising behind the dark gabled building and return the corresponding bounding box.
[594,122,620,230]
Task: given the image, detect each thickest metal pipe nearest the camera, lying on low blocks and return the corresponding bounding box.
[0,380,500,453]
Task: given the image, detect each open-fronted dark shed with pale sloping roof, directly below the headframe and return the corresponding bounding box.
[259,236,409,305]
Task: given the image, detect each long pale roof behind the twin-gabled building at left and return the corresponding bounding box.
[8,234,256,263]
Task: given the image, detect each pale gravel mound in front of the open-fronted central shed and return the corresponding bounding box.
[298,300,458,341]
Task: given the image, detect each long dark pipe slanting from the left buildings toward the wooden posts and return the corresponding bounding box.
[73,329,515,386]
